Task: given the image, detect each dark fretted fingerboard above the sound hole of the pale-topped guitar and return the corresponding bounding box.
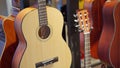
[38,0,48,26]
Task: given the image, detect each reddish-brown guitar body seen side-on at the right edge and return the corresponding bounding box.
[98,0,120,68]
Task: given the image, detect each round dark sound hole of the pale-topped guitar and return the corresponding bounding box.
[38,25,50,39]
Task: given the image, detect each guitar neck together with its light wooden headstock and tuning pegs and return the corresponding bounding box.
[77,10,91,68]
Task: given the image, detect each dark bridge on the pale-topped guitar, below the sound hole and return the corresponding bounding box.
[36,57,58,68]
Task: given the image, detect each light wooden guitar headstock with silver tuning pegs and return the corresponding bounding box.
[76,10,91,34]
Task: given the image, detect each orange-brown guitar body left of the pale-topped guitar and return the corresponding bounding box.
[0,16,18,68]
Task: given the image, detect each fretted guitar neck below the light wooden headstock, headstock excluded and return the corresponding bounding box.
[84,33,91,68]
